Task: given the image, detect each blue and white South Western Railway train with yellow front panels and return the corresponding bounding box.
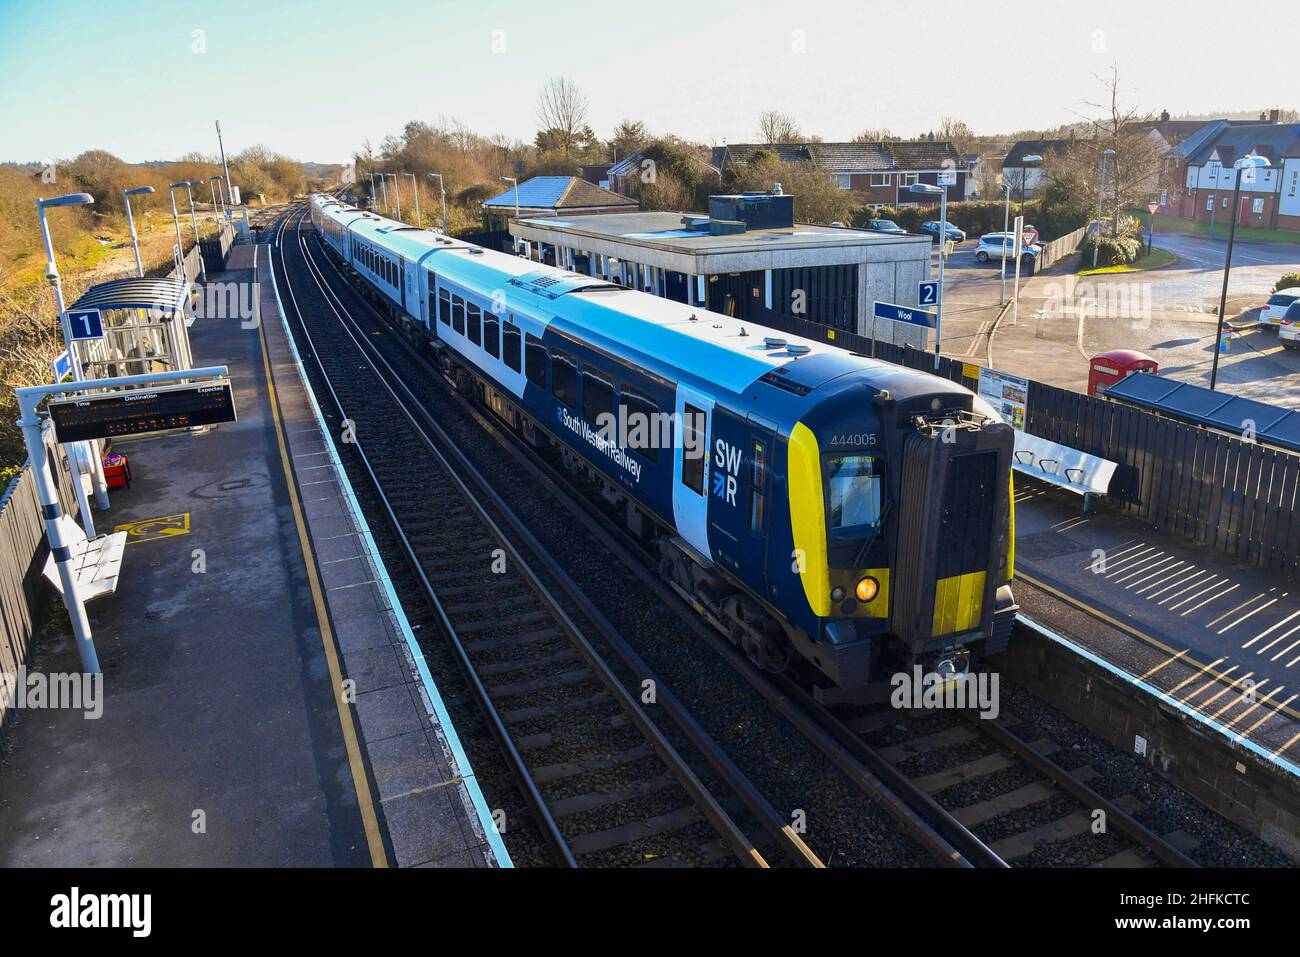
[311,195,1017,688]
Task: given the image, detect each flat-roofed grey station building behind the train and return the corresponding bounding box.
[510,186,931,348]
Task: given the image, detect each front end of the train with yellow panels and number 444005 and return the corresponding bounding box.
[787,392,1017,688]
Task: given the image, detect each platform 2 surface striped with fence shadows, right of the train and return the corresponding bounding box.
[1015,476,1300,775]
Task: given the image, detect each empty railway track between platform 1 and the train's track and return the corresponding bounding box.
[273,211,822,867]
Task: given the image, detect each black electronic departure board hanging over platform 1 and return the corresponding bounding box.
[48,378,237,442]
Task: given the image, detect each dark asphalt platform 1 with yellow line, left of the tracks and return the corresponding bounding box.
[0,246,510,867]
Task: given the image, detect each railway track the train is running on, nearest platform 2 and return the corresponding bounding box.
[276,205,1195,867]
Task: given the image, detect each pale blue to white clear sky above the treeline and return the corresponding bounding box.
[0,0,1300,163]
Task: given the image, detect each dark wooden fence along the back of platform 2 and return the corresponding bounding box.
[774,306,1300,577]
